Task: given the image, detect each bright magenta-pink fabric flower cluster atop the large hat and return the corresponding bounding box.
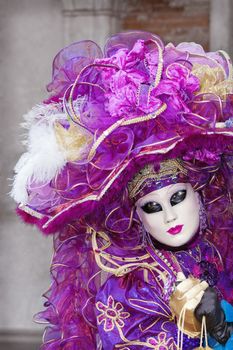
[95,40,200,118]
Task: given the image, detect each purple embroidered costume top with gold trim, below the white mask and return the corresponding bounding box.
[96,238,233,350]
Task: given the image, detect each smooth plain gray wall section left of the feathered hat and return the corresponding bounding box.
[0,0,63,330]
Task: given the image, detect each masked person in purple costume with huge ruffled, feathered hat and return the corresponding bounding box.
[12,32,233,350]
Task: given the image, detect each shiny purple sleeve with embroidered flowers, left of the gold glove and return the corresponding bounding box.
[96,272,199,350]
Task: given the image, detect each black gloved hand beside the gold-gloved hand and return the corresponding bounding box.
[194,287,233,345]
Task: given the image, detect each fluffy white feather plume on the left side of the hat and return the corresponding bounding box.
[11,104,66,204]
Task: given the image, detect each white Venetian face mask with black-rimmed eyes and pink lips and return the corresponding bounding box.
[136,183,200,247]
